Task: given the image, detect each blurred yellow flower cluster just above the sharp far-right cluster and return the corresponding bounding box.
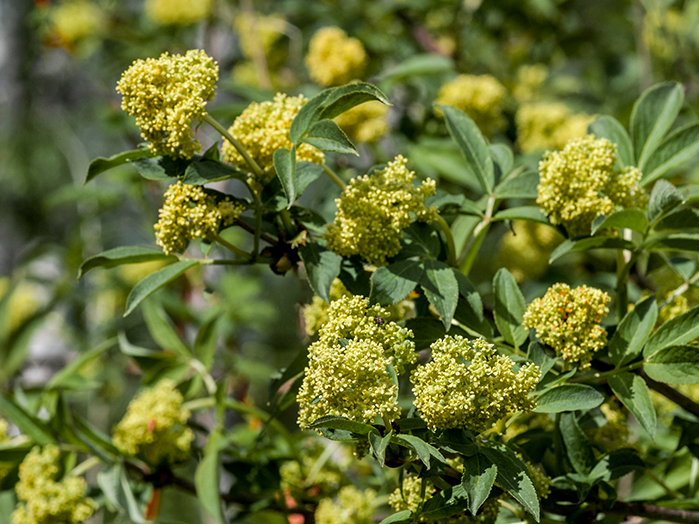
[515,102,593,153]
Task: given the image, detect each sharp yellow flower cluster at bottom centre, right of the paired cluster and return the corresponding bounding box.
[410,335,541,433]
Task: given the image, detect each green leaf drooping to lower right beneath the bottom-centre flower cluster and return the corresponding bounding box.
[481,441,539,522]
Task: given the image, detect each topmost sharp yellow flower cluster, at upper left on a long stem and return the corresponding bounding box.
[117,50,218,157]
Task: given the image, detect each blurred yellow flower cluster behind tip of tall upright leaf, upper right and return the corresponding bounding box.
[435,75,507,135]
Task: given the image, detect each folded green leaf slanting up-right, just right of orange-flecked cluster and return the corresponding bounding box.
[609,295,658,367]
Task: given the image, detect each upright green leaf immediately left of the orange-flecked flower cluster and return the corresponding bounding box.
[493,267,529,347]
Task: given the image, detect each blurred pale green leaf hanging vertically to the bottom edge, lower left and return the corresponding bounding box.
[194,427,228,524]
